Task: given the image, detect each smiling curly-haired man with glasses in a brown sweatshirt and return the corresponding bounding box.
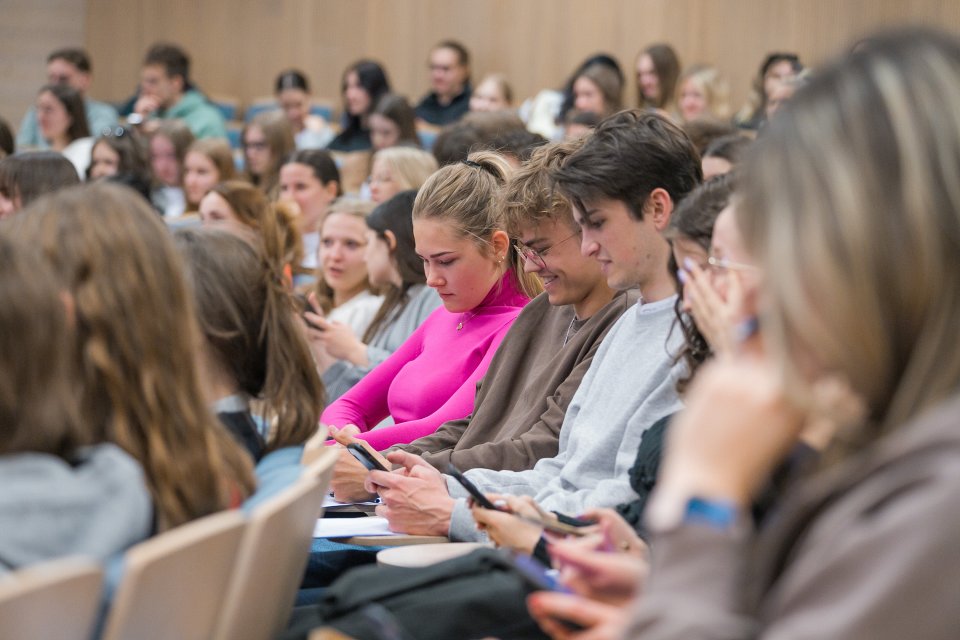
[333,143,637,500]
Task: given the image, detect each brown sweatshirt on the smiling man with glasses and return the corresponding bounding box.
[397,290,639,471]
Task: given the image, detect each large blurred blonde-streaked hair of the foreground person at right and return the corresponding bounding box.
[738,30,960,445]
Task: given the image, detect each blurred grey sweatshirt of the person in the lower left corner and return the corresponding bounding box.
[0,444,153,574]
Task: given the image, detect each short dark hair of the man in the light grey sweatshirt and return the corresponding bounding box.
[551,109,703,220]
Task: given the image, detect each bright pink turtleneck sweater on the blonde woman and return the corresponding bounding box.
[320,272,529,451]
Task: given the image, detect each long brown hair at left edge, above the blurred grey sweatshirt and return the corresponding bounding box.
[0,235,81,459]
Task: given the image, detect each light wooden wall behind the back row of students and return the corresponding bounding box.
[0,0,960,135]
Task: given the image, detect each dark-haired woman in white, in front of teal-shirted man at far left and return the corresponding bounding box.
[36,84,93,176]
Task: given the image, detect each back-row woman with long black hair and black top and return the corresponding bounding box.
[327,60,390,151]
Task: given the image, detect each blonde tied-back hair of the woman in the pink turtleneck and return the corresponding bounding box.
[413,151,543,298]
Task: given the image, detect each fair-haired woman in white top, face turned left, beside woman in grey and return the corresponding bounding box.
[306,198,383,340]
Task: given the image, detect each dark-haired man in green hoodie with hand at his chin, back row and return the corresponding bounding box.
[128,43,227,138]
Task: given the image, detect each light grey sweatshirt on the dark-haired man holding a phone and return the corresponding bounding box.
[447,296,686,540]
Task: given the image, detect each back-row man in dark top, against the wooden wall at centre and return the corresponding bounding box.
[415,40,472,127]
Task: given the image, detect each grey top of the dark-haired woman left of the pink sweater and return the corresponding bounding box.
[322,284,441,403]
